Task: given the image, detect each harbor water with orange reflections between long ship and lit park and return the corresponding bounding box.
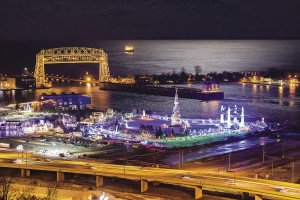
[0,83,300,124]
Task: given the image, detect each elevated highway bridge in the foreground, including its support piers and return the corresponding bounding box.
[0,157,300,200]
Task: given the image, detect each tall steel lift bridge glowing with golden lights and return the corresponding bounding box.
[34,47,110,88]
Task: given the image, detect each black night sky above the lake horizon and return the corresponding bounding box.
[0,0,300,40]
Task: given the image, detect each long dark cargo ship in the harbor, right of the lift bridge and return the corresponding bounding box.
[99,82,224,101]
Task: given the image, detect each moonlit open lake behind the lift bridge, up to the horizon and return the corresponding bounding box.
[0,40,300,77]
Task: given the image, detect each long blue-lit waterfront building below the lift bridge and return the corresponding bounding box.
[39,93,91,110]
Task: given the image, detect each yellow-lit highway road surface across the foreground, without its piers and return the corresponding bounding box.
[0,151,300,199]
